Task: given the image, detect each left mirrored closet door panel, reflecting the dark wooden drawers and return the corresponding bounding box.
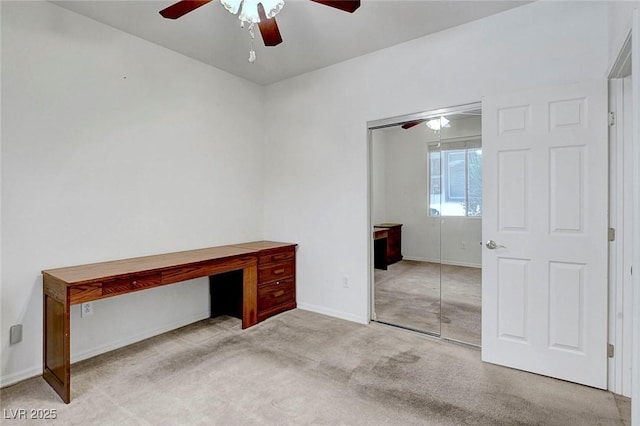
[371,123,441,336]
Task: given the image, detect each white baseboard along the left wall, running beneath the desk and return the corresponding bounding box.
[0,311,210,388]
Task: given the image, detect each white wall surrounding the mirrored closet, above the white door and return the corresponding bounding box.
[265,2,608,322]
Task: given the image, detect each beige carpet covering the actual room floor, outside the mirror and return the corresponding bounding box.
[0,310,626,426]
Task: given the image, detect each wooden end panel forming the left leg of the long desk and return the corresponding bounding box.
[42,276,71,404]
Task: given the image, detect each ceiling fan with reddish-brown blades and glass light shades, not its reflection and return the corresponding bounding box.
[160,0,360,47]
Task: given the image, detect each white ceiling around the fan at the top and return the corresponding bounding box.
[53,0,529,85]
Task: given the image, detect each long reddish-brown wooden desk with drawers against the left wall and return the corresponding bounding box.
[42,241,296,403]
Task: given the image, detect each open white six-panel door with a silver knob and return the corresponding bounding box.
[482,80,608,389]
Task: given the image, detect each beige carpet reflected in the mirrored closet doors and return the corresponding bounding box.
[375,260,482,345]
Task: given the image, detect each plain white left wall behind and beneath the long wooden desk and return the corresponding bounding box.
[0,2,264,385]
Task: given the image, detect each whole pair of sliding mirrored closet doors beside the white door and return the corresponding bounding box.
[370,104,482,345]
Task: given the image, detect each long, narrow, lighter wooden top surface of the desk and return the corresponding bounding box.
[42,241,296,285]
